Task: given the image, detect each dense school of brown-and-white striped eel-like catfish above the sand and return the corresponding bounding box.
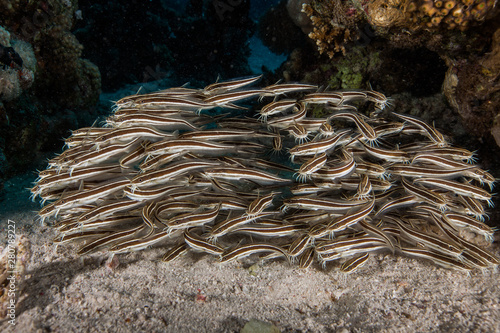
[32,77,499,273]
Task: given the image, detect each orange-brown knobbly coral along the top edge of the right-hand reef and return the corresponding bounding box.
[303,0,498,58]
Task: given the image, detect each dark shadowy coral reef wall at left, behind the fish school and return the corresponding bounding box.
[0,0,101,178]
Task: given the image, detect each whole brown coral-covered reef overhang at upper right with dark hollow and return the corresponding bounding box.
[284,0,500,148]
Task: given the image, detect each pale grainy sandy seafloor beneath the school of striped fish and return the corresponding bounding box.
[0,175,500,332]
